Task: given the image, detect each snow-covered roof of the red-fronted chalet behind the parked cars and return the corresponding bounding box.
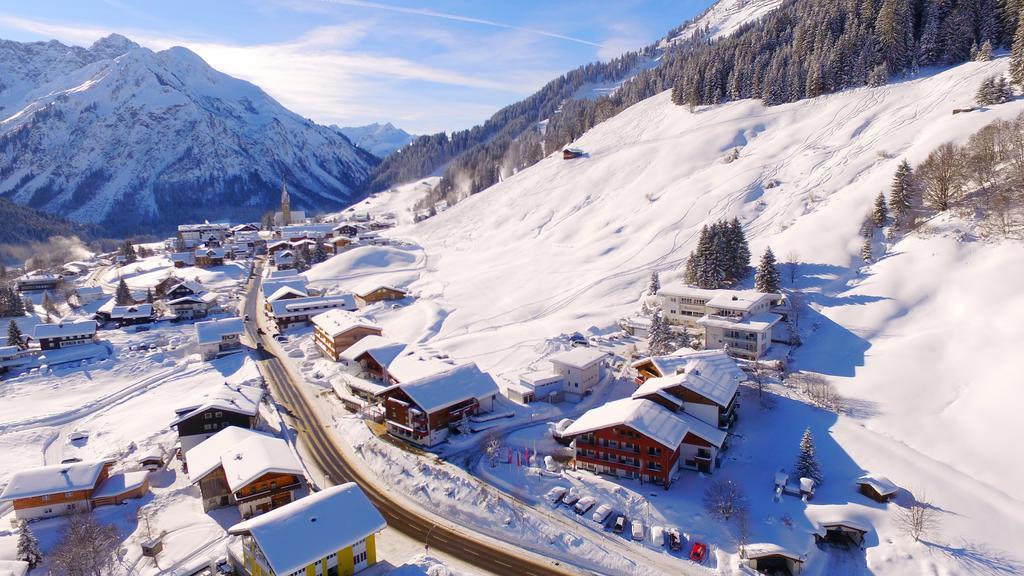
[562,398,690,450]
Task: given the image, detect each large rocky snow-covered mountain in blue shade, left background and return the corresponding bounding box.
[0,35,377,234]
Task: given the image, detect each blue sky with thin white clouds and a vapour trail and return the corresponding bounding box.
[0,0,711,133]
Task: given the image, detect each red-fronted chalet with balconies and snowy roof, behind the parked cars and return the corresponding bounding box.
[562,398,726,488]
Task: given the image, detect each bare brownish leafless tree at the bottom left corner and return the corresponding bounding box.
[50,512,121,576]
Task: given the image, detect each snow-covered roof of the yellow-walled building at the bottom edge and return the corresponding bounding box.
[228,482,387,574]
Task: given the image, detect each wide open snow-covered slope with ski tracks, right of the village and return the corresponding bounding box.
[333,58,1024,574]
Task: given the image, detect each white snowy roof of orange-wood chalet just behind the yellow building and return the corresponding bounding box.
[185,426,304,492]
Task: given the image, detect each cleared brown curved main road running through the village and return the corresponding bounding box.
[245,260,574,576]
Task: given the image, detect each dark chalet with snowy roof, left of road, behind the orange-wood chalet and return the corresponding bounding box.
[171,382,263,454]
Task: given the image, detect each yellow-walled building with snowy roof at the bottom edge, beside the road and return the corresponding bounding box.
[227,482,387,576]
